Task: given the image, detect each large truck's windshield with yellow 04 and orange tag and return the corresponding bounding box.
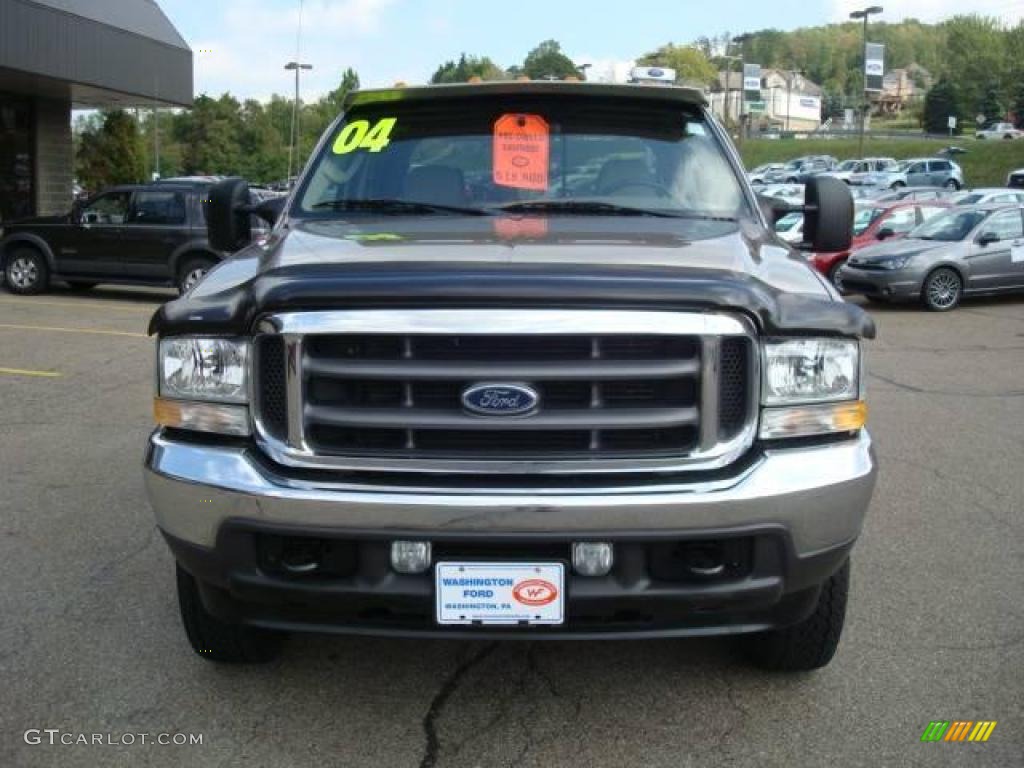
[293,96,749,219]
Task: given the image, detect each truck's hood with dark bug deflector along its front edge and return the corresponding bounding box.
[151,216,874,336]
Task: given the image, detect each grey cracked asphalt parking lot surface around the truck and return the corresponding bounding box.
[0,289,1024,768]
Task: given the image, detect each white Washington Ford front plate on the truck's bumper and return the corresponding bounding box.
[434,562,565,626]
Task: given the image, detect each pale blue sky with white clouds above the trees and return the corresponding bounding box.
[157,0,1024,99]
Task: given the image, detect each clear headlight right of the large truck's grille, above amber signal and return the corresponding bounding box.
[763,339,860,406]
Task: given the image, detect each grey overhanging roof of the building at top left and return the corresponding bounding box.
[0,0,193,109]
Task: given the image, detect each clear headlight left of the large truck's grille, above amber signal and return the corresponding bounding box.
[159,336,249,402]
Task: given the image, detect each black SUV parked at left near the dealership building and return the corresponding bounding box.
[0,182,230,294]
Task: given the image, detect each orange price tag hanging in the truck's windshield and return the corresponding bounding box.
[494,115,551,189]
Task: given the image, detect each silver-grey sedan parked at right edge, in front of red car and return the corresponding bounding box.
[840,205,1024,311]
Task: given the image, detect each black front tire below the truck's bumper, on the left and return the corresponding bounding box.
[175,564,285,664]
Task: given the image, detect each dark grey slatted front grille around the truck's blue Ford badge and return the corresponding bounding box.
[255,310,755,473]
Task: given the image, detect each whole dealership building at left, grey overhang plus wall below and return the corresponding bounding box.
[0,0,193,222]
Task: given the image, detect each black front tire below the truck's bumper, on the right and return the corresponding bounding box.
[742,560,850,672]
